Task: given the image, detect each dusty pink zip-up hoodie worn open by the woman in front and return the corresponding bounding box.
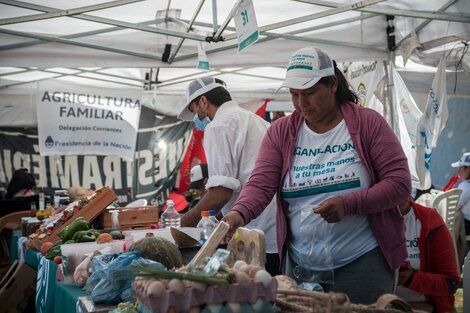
[232,102,411,270]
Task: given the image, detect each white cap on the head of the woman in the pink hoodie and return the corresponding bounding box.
[277,47,335,90]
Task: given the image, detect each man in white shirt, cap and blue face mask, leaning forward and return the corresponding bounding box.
[178,76,279,274]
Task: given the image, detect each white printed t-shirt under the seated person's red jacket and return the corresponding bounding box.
[395,208,426,302]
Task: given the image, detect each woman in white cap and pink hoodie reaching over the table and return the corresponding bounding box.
[222,47,411,304]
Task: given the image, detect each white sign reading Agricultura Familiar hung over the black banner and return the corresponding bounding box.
[36,83,142,160]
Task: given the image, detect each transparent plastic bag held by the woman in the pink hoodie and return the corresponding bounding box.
[293,206,334,284]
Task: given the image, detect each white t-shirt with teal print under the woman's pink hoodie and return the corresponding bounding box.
[281,120,377,271]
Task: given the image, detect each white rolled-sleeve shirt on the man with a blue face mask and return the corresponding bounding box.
[204,101,277,253]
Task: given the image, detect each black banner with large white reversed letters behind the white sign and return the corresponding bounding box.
[0,107,193,205]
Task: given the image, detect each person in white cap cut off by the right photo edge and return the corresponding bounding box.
[451,152,470,251]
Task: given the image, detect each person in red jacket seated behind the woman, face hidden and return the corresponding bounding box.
[396,199,460,313]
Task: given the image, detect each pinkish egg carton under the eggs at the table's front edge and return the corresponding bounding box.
[134,279,277,313]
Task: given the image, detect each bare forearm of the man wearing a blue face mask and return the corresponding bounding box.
[181,186,233,227]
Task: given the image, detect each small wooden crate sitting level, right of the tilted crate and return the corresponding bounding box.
[95,205,159,229]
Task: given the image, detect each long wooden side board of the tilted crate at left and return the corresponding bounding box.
[42,187,117,243]
